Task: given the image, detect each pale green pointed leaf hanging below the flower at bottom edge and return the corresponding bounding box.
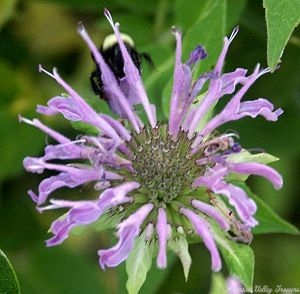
[126,232,154,294]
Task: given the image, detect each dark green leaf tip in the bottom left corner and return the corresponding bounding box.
[0,250,21,294]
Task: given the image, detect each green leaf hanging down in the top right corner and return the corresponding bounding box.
[264,0,300,71]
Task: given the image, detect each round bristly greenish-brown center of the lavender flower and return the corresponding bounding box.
[128,125,204,205]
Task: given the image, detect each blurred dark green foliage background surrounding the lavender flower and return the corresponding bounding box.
[0,0,300,294]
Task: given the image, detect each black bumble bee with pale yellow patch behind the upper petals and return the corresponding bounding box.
[90,34,152,101]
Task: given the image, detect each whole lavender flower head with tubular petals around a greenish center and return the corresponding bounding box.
[20,10,282,282]
